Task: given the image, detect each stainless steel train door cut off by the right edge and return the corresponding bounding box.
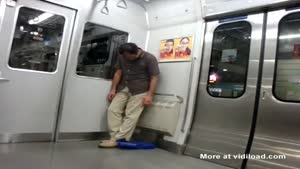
[247,8,300,169]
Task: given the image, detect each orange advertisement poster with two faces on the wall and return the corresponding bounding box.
[159,37,193,62]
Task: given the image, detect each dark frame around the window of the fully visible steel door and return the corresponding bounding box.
[206,20,252,99]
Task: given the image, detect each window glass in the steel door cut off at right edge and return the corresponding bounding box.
[273,13,300,101]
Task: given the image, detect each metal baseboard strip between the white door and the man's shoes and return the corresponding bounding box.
[57,132,109,142]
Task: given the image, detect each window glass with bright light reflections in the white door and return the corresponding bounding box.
[8,7,65,72]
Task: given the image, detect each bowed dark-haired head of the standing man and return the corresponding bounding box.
[119,43,139,60]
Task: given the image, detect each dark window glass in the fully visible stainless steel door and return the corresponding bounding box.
[207,21,251,98]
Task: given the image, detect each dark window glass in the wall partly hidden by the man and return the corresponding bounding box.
[76,23,128,79]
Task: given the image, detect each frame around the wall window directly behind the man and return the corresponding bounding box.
[73,21,130,81]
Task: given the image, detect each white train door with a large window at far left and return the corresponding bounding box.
[0,0,76,142]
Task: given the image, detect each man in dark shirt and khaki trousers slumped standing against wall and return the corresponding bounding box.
[99,43,159,148]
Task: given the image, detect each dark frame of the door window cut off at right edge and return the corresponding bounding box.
[272,11,300,103]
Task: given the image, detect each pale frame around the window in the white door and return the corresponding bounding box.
[5,5,68,74]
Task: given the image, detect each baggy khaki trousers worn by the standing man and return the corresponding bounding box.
[108,87,147,141]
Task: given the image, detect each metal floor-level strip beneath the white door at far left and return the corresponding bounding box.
[0,133,52,143]
